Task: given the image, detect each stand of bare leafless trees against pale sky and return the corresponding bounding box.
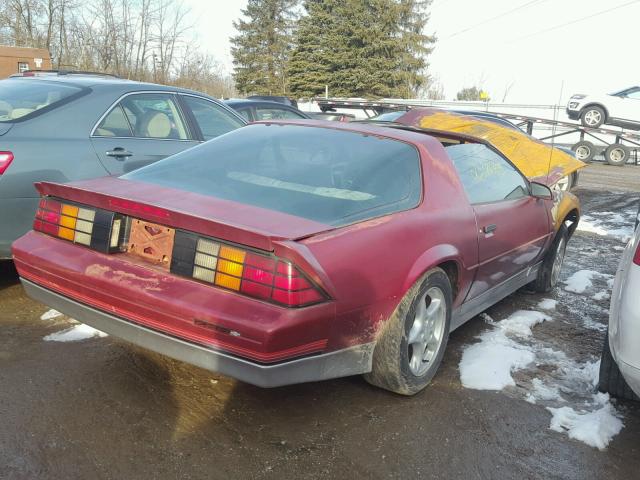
[0,0,233,96]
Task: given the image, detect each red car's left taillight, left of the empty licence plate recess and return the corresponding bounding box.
[33,198,125,252]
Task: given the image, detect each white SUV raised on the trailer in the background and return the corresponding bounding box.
[567,87,640,130]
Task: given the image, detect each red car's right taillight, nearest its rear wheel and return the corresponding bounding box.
[171,230,326,307]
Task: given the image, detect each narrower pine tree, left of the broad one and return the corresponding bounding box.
[231,0,299,95]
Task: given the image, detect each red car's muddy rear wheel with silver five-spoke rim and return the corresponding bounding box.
[364,268,453,395]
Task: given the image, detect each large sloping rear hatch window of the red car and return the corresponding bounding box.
[122,124,422,226]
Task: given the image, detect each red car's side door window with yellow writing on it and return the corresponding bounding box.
[446,143,529,204]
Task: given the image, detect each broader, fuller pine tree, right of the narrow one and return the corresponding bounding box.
[289,0,434,97]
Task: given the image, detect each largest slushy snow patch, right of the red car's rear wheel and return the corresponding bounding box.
[460,310,624,450]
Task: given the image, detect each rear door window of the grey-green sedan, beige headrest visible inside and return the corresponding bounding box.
[95,93,189,140]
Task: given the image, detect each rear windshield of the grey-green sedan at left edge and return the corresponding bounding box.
[0,79,82,123]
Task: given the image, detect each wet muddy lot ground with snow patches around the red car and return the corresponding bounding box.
[0,165,640,479]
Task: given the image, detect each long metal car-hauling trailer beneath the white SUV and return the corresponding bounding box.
[312,98,640,166]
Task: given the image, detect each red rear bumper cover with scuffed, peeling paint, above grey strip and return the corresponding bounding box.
[13,232,340,364]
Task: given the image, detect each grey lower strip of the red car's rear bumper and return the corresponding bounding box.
[22,278,373,388]
